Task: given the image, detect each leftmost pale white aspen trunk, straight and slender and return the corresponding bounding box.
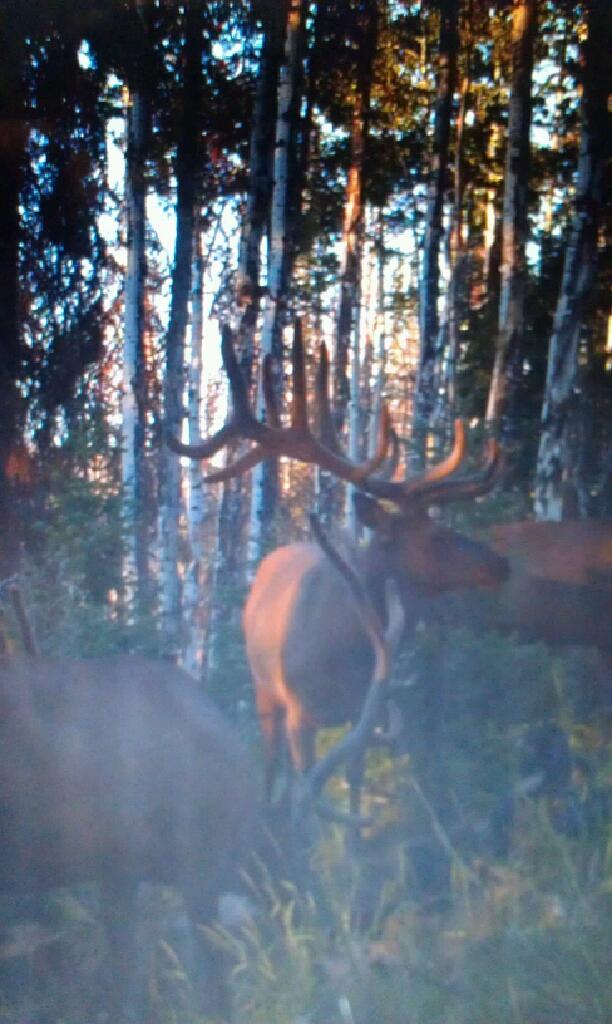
[122,51,149,615]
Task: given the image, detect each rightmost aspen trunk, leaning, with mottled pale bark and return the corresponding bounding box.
[534,0,610,519]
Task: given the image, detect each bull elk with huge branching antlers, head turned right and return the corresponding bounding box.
[170,324,508,795]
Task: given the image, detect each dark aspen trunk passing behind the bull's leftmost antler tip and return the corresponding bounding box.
[160,0,204,659]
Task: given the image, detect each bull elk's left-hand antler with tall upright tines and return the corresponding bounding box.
[167,321,391,485]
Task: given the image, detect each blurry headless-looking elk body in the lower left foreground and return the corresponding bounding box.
[0,655,257,1020]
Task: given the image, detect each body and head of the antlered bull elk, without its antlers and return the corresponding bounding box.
[244,498,506,787]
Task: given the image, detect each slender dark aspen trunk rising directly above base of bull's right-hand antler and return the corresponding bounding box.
[414,0,458,436]
